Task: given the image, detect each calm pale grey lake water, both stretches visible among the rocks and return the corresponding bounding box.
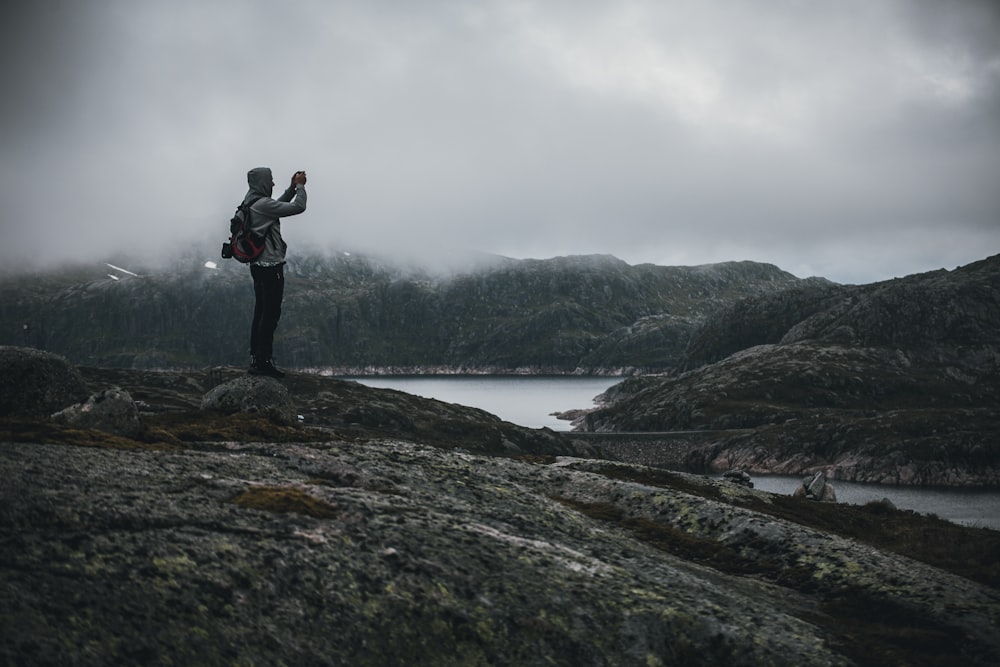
[340,375,1000,530]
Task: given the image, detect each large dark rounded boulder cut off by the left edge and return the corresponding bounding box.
[0,345,87,417]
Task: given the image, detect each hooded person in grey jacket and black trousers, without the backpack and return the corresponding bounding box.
[243,167,306,378]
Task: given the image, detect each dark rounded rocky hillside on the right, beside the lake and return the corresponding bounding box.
[586,257,1000,485]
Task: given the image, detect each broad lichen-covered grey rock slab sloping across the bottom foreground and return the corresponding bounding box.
[0,441,1000,666]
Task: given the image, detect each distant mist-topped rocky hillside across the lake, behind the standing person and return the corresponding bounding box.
[0,255,799,372]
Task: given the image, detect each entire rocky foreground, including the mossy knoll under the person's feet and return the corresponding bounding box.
[0,349,1000,665]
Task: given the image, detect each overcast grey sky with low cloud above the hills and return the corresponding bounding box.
[0,0,1000,283]
